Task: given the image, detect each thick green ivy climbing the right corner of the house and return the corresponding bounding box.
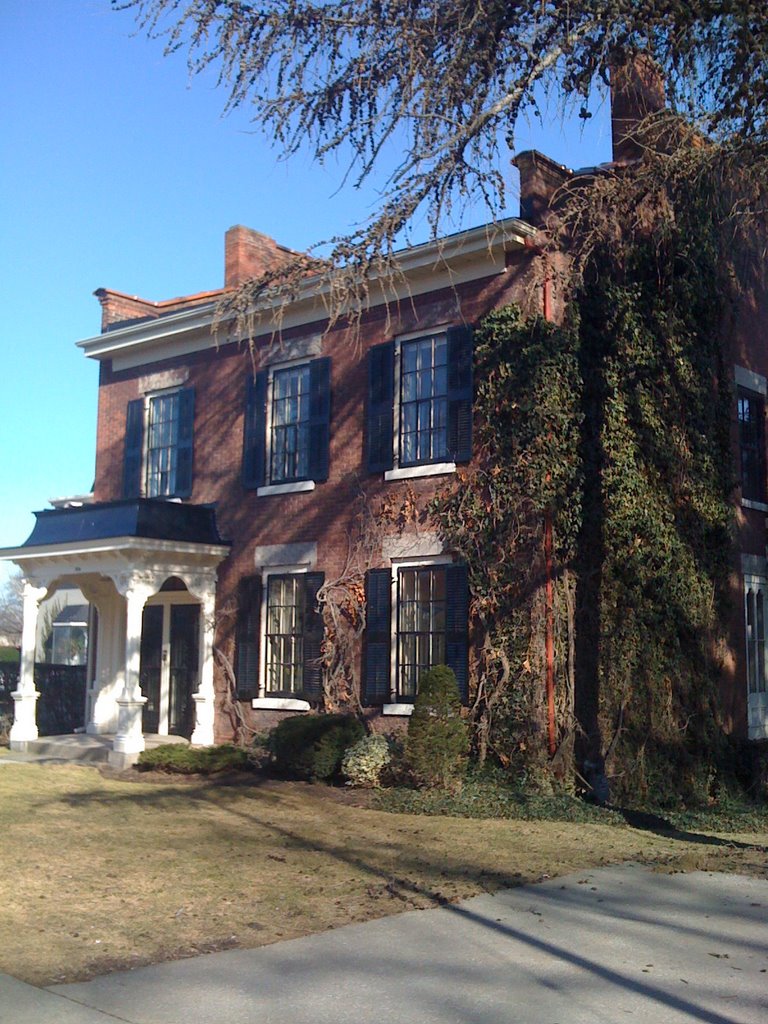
[431,138,749,803]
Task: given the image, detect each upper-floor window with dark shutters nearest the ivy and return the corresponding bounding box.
[366,327,472,475]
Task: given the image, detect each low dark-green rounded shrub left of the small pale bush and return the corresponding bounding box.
[269,715,366,779]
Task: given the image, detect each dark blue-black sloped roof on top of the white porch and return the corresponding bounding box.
[23,498,228,548]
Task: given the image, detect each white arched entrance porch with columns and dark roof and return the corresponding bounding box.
[0,499,229,767]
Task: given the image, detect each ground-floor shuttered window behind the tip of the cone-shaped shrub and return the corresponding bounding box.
[364,562,468,705]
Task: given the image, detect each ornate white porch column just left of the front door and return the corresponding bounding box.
[110,580,155,768]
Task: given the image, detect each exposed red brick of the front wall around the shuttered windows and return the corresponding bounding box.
[95,254,530,738]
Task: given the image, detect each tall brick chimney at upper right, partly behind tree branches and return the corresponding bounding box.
[610,53,667,163]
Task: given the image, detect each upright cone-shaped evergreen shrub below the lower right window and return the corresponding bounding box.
[406,665,469,788]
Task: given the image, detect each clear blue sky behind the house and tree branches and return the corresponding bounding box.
[0,0,610,580]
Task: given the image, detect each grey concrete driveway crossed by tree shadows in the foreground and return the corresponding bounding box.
[0,865,768,1024]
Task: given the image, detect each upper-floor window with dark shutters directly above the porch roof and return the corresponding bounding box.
[123,388,195,498]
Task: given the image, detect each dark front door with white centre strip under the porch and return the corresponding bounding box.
[139,604,200,739]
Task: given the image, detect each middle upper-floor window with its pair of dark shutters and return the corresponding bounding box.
[243,357,331,487]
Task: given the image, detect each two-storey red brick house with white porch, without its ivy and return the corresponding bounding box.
[3,70,768,764]
